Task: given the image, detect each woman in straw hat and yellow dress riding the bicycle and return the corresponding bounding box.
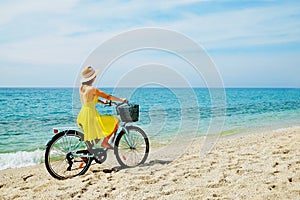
[77,66,127,148]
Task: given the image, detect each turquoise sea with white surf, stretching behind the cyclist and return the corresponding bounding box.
[0,87,300,170]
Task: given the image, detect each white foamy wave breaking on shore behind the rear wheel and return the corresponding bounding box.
[0,149,44,170]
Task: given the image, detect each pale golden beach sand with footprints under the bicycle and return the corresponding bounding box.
[0,127,300,199]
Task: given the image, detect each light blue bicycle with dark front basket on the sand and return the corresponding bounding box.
[45,100,149,179]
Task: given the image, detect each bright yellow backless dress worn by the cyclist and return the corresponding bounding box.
[77,96,120,141]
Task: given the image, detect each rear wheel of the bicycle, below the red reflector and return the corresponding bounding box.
[45,130,93,179]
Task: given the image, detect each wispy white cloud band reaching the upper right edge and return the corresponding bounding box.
[165,4,300,49]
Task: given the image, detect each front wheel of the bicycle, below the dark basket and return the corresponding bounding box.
[114,126,149,167]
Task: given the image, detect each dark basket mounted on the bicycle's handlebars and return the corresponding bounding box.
[118,104,139,122]
